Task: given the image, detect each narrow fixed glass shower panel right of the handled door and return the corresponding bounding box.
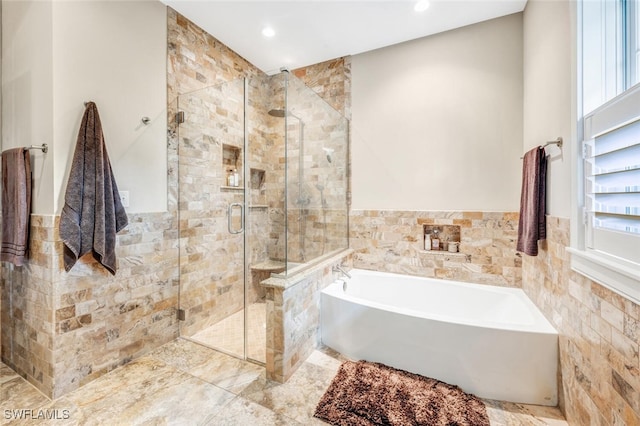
[245,75,287,363]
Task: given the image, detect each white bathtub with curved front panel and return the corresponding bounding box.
[320,269,558,406]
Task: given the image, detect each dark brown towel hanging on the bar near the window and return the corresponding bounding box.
[516,147,547,256]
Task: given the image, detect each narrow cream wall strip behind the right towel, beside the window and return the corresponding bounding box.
[523,0,576,218]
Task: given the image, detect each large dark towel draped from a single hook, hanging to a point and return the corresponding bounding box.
[60,102,128,275]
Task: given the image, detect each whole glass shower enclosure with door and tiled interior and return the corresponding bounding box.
[177,72,349,363]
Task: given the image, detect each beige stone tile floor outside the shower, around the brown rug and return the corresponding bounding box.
[0,339,567,426]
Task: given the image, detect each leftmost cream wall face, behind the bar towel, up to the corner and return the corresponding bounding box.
[2,1,54,213]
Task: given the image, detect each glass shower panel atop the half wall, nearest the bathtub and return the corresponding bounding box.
[285,76,349,273]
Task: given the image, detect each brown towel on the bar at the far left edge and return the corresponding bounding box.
[0,148,31,266]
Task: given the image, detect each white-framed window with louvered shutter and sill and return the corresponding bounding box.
[571,0,640,300]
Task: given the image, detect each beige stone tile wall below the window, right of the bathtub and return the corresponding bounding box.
[522,217,640,425]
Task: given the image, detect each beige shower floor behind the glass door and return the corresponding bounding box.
[190,303,267,363]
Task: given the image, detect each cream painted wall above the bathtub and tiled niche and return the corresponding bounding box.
[352,14,523,211]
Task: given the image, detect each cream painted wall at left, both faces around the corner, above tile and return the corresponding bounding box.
[2,0,167,214]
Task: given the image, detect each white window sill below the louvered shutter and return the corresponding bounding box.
[567,247,640,303]
